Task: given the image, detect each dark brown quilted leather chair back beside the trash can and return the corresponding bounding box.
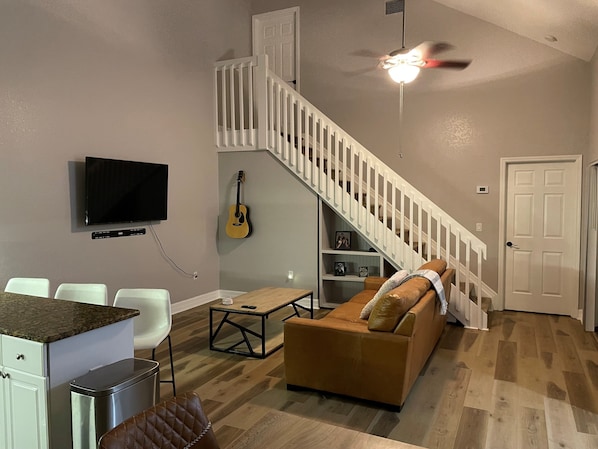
[98,391,220,449]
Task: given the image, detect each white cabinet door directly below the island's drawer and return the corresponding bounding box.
[0,368,49,449]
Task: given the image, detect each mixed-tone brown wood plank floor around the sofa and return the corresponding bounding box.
[142,305,598,449]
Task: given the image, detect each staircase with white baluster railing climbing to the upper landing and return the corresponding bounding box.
[214,55,496,329]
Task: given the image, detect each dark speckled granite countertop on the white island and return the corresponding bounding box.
[0,292,139,343]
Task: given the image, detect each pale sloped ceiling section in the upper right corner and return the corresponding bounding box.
[436,0,598,61]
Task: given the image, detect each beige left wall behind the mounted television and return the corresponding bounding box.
[0,0,251,302]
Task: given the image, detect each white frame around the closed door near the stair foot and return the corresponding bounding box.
[500,154,582,318]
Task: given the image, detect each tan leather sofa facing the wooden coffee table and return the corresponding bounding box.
[284,259,454,409]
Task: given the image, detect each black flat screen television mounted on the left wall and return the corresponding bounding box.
[85,156,168,225]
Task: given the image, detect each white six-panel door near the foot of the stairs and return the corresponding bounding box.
[504,159,581,317]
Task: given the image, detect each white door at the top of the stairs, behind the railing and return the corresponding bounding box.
[253,7,299,91]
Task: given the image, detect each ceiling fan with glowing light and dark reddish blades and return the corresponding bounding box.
[378,0,471,84]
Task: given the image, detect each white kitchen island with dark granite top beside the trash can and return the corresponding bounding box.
[0,293,139,449]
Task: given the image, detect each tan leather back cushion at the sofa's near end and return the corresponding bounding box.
[368,277,431,332]
